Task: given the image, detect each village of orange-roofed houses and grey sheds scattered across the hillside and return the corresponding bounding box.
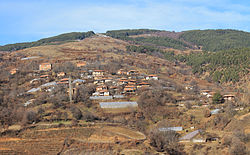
[5,57,243,143]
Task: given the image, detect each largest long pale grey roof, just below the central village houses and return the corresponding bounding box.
[99,102,138,108]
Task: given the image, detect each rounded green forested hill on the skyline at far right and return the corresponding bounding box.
[179,30,250,51]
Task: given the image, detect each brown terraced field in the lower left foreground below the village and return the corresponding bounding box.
[0,126,145,155]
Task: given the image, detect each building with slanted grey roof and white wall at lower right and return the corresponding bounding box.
[179,129,206,143]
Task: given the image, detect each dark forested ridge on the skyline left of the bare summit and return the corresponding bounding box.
[0,31,95,51]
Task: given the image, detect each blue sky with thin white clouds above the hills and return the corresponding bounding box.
[0,0,250,45]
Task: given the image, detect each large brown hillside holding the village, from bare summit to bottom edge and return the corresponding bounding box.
[0,30,250,155]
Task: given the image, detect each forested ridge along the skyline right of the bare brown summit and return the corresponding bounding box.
[106,29,250,51]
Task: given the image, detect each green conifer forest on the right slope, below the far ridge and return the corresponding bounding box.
[176,48,250,83]
